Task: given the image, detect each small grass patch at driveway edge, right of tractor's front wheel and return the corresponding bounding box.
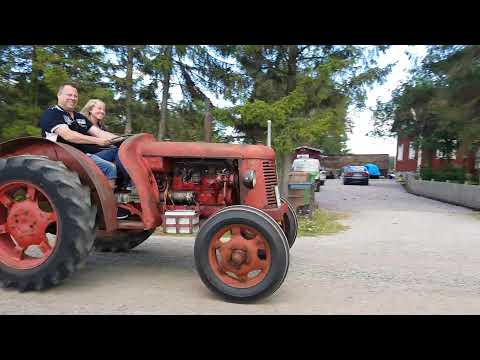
[298,209,348,236]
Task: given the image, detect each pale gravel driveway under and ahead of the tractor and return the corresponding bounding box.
[0,180,480,314]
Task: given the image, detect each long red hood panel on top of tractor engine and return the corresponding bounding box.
[137,134,275,160]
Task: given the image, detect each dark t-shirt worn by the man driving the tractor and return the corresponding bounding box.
[39,105,103,154]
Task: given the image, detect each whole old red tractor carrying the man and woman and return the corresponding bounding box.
[0,134,298,302]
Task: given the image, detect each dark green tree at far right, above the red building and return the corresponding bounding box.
[373,45,480,162]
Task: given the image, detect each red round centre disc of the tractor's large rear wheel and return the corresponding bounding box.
[6,200,45,248]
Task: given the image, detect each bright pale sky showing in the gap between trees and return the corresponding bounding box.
[347,45,426,156]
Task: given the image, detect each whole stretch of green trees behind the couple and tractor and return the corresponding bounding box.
[0,45,388,153]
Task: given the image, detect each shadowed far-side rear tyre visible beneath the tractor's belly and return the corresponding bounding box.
[94,230,155,252]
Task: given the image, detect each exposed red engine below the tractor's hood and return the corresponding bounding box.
[156,159,238,216]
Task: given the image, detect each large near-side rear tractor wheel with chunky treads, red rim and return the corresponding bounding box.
[0,155,96,291]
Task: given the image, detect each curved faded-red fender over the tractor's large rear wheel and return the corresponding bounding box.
[0,137,118,232]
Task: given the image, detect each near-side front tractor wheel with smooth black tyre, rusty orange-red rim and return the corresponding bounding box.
[194,205,289,303]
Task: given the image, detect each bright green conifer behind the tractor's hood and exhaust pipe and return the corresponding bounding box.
[212,45,390,158]
